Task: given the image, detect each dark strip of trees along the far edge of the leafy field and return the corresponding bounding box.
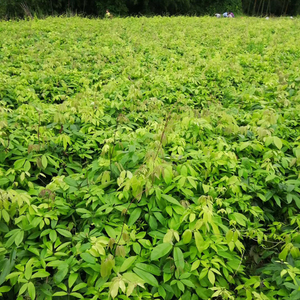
[0,0,300,18]
